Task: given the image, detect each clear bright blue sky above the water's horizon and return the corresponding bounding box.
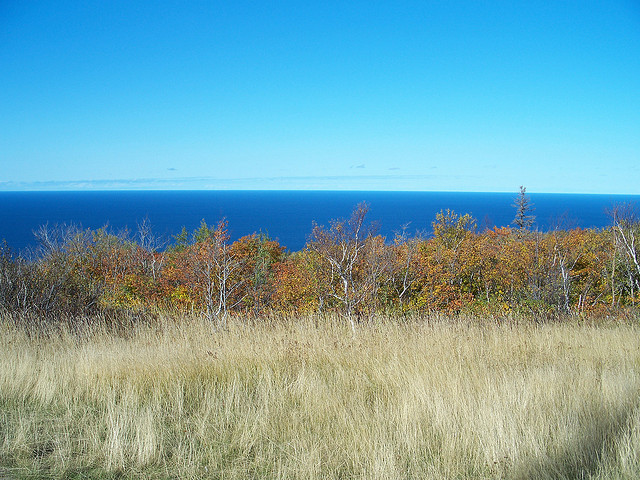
[0,0,640,194]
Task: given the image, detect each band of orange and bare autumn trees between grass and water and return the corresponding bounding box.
[0,197,640,326]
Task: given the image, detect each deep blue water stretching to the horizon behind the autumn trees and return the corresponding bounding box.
[0,191,640,255]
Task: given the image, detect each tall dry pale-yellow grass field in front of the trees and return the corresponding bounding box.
[0,318,640,479]
